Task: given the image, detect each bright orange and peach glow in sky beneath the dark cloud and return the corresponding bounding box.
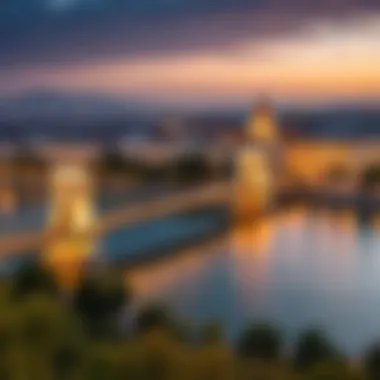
[3,17,380,102]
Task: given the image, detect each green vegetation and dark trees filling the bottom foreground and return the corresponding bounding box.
[0,263,380,380]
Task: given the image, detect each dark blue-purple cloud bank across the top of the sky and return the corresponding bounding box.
[0,0,380,68]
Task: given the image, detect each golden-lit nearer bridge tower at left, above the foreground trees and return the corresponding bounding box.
[44,147,97,285]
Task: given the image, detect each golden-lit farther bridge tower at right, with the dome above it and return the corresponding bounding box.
[234,95,280,219]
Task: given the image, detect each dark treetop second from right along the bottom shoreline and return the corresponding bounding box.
[294,329,337,369]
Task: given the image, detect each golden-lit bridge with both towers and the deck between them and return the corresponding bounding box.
[0,96,290,263]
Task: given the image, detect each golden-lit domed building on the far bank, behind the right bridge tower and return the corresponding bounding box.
[244,97,380,191]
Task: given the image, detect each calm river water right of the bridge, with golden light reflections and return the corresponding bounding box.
[127,207,380,354]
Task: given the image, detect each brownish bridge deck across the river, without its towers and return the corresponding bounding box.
[0,181,232,258]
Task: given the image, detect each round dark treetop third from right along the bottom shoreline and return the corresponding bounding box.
[238,324,282,360]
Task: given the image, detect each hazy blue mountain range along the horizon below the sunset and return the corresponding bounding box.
[0,89,380,141]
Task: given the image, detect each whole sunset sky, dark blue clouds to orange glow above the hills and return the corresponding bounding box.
[0,0,380,106]
